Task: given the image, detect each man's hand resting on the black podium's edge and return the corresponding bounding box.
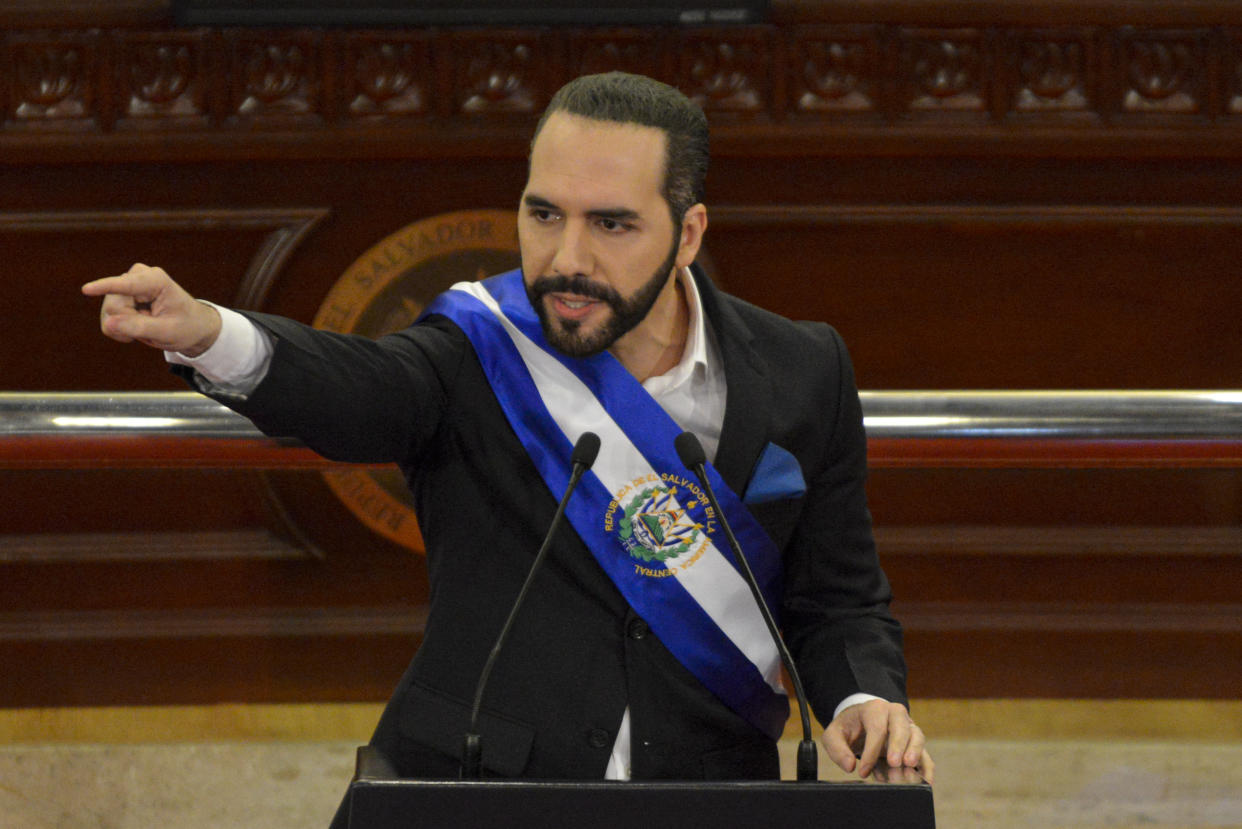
[823,700,935,783]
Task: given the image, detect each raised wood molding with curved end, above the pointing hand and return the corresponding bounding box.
[0,208,330,308]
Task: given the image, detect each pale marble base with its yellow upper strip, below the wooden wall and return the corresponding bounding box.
[0,700,1242,829]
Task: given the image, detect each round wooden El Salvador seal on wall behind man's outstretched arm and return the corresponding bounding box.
[313,210,520,552]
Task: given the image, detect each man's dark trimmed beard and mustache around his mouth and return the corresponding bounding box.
[527,236,677,358]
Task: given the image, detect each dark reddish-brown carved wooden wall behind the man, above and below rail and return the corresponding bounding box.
[0,0,1242,706]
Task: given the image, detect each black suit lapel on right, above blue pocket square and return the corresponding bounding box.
[692,266,774,497]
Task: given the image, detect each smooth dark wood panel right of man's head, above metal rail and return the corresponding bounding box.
[710,206,1242,389]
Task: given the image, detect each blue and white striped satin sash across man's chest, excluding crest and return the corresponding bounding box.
[424,271,789,738]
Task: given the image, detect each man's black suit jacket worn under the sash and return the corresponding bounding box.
[196,267,905,779]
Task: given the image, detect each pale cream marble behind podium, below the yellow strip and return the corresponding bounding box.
[0,740,1242,829]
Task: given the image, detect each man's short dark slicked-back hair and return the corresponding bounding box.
[532,72,708,227]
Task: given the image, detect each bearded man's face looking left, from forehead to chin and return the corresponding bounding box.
[518,112,698,357]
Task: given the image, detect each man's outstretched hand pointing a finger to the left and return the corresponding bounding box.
[82,265,220,357]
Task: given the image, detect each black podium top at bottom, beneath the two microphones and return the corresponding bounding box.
[347,746,935,829]
